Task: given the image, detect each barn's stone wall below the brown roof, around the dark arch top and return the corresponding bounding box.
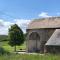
[27,29,55,52]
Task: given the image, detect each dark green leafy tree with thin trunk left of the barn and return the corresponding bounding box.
[8,24,24,51]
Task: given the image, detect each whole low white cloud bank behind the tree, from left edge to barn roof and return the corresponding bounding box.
[0,19,31,35]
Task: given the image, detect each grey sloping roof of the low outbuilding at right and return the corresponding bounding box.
[45,29,60,46]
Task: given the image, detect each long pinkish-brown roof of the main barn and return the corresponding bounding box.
[27,17,60,29]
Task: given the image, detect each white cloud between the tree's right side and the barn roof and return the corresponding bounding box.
[14,19,31,33]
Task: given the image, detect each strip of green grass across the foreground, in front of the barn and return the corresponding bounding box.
[0,54,60,60]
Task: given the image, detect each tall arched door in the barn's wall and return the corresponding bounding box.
[29,32,40,52]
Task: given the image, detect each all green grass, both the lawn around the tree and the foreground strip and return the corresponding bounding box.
[0,41,60,60]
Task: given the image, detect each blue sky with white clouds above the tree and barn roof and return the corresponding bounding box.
[0,0,60,35]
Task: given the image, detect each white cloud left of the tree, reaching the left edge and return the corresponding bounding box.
[0,19,12,35]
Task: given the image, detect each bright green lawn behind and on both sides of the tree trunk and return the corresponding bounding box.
[0,41,26,52]
